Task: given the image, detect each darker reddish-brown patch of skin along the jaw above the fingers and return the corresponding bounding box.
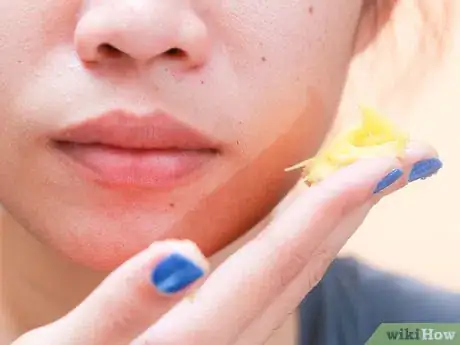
[166,102,329,255]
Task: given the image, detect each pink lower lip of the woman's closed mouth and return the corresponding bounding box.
[57,143,216,188]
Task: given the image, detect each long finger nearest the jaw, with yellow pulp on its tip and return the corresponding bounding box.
[134,157,399,345]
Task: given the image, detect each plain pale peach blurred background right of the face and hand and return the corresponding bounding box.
[338,0,460,291]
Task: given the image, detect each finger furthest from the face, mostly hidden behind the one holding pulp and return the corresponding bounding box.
[235,142,437,345]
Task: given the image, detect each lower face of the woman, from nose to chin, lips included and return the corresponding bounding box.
[0,0,361,269]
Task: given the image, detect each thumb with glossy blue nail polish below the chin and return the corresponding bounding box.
[16,241,208,345]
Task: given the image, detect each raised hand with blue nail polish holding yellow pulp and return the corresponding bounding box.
[13,143,436,345]
